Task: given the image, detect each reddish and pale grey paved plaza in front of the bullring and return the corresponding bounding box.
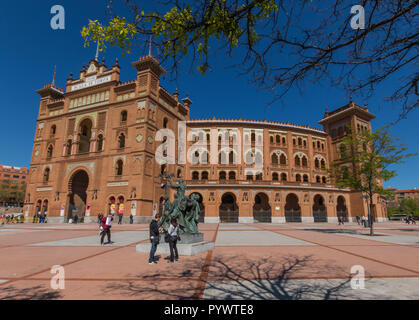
[0,222,419,300]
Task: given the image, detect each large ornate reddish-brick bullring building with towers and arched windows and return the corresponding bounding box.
[24,55,387,223]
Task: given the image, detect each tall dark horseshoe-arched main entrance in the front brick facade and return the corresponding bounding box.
[67,170,89,222]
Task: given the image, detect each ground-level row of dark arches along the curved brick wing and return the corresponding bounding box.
[182,189,366,223]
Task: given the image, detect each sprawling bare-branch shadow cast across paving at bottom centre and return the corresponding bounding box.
[105,255,351,300]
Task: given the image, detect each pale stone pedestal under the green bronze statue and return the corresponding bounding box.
[136,233,214,256]
